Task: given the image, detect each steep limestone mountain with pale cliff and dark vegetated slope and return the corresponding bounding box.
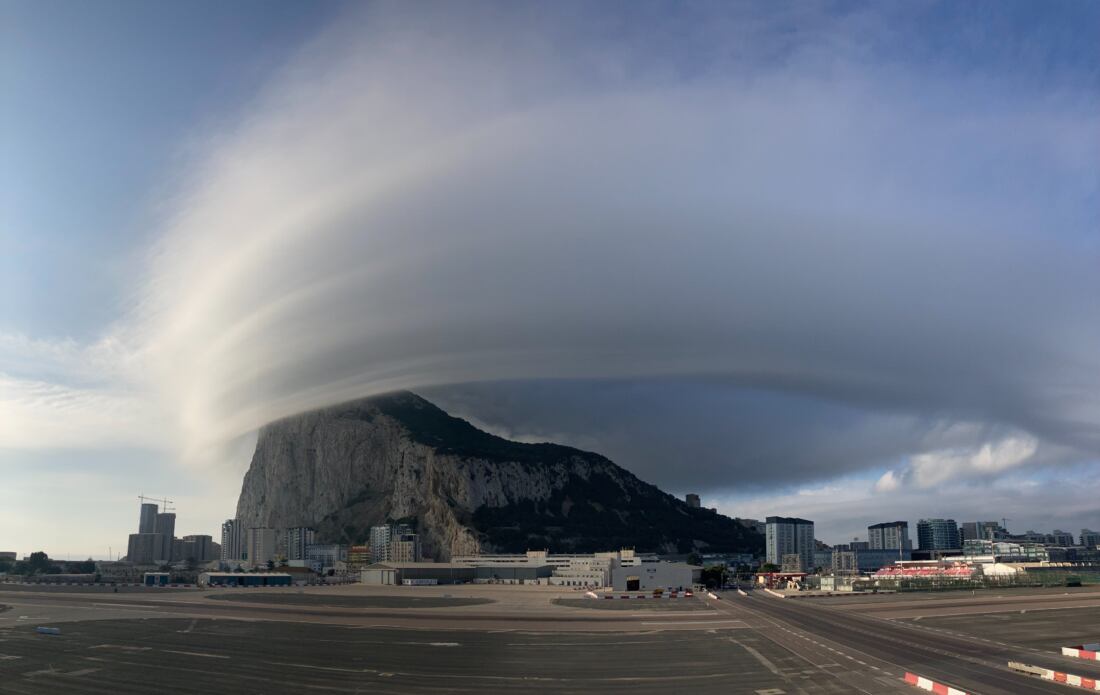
[237,391,761,560]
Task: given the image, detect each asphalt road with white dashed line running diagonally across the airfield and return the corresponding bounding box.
[716,593,1100,695]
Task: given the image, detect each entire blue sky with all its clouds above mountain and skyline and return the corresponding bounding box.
[0,2,1100,555]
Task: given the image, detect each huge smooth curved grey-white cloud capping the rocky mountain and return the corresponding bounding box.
[128,2,1100,470]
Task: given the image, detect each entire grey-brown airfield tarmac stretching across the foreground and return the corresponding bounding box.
[0,585,1100,695]
